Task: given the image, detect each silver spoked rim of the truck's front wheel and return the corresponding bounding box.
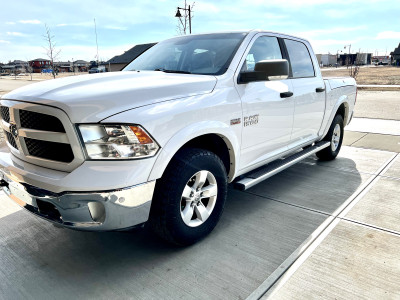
[181,170,218,227]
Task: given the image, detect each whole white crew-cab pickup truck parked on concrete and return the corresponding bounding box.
[0,30,356,245]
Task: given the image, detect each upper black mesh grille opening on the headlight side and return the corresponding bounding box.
[19,110,65,132]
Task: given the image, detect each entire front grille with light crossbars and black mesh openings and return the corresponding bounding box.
[0,100,85,172]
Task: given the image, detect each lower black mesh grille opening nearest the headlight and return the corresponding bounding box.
[25,138,74,163]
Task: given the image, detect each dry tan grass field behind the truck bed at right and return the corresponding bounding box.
[322,66,400,85]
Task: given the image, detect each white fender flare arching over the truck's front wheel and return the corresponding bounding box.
[148,121,240,181]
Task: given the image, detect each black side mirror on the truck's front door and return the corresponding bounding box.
[239,59,289,83]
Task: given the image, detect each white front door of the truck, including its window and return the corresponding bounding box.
[236,35,294,170]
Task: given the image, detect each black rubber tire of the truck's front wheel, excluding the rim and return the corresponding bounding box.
[149,148,227,246]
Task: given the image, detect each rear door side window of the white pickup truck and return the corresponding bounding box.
[285,39,315,78]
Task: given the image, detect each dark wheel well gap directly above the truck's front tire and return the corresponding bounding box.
[182,134,234,177]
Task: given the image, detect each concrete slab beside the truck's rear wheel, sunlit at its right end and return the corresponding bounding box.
[302,146,395,174]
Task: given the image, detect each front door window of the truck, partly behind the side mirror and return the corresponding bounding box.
[242,36,282,71]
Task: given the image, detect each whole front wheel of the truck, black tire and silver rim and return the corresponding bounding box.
[149,148,227,246]
